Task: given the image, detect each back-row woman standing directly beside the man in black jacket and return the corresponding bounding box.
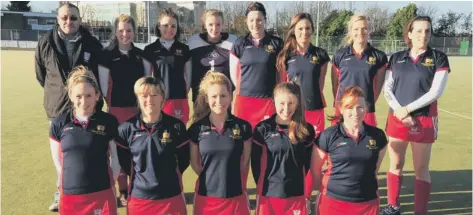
[98,14,152,207]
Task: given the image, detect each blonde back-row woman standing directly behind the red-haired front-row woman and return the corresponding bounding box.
[332,15,388,126]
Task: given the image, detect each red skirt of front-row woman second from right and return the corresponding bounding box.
[256,196,307,215]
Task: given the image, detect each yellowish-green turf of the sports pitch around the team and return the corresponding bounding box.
[1,51,472,215]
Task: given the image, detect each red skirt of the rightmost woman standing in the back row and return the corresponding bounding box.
[386,113,438,143]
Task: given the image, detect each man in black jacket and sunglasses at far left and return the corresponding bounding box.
[35,3,103,211]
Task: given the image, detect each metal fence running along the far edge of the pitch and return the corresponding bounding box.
[1,27,472,56]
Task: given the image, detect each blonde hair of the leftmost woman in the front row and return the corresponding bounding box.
[66,65,100,96]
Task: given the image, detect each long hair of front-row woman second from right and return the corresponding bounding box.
[273,82,309,144]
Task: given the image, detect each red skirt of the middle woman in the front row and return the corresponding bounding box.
[194,193,250,215]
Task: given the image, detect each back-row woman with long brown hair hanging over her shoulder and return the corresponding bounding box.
[277,13,330,204]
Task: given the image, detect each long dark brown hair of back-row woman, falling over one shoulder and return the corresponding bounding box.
[276,13,314,82]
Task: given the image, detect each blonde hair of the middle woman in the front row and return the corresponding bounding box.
[192,71,232,123]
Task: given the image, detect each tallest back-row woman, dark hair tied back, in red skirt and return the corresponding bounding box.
[230,2,283,127]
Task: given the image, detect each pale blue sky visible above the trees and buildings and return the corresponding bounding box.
[1,1,472,17]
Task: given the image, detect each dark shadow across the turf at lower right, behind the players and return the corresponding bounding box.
[185,170,472,215]
